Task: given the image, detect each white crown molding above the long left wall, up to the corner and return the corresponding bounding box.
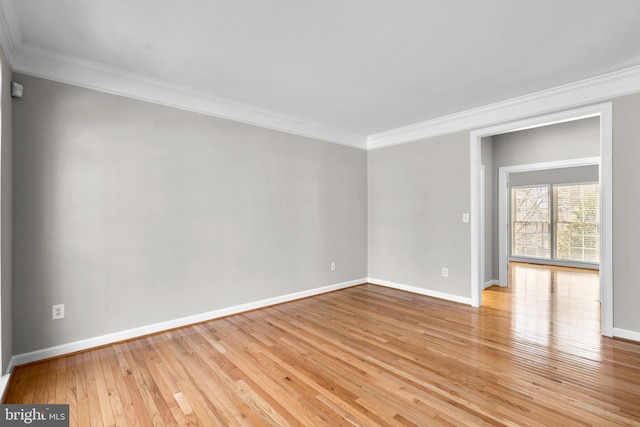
[0,0,367,149]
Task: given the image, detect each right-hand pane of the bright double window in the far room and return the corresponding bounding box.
[553,184,600,262]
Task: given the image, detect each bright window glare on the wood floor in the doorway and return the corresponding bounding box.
[483,263,601,352]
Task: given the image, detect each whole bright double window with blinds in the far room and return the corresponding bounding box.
[511,183,600,263]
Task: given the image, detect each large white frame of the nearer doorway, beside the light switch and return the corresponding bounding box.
[470,102,613,337]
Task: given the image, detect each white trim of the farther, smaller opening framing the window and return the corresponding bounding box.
[498,157,600,286]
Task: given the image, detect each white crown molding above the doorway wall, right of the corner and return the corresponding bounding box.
[367,66,640,150]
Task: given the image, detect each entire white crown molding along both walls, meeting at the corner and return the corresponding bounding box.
[0,0,640,150]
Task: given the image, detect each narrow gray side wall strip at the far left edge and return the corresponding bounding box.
[0,43,13,372]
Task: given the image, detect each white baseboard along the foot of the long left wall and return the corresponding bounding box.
[6,278,367,374]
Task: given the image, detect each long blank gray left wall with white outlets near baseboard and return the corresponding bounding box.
[13,75,368,354]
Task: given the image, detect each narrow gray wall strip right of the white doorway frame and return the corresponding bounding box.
[613,94,640,333]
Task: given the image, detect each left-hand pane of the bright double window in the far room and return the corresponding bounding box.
[511,186,551,258]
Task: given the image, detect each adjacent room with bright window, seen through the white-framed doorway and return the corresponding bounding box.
[481,117,602,354]
